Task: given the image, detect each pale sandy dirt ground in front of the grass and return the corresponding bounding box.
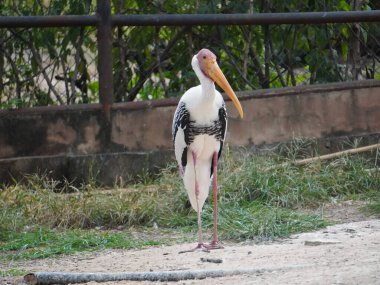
[0,202,380,285]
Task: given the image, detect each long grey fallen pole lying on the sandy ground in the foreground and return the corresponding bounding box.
[24,266,303,285]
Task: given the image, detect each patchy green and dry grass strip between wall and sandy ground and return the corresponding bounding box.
[0,141,380,260]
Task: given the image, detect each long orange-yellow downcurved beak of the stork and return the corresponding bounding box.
[206,60,243,118]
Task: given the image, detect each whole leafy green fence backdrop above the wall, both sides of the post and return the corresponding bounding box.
[0,0,380,108]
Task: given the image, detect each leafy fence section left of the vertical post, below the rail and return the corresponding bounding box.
[0,28,98,108]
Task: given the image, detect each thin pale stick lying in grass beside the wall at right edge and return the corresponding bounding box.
[265,143,380,171]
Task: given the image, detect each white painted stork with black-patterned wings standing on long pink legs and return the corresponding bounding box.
[172,49,243,252]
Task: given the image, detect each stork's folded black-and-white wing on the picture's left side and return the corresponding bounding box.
[172,102,190,174]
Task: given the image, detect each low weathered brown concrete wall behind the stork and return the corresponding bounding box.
[0,80,380,184]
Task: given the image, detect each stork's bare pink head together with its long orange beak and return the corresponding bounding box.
[196,48,243,118]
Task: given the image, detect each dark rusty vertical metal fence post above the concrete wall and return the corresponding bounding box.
[96,0,113,120]
